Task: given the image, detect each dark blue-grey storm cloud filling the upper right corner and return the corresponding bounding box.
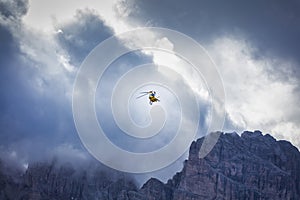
[124,0,300,75]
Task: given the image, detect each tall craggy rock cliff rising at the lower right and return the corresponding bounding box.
[167,131,300,199]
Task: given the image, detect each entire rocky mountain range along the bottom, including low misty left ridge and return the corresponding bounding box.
[0,131,300,200]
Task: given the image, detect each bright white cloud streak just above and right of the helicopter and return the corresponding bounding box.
[116,29,209,101]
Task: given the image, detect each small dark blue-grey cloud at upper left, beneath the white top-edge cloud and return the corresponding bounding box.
[57,9,113,65]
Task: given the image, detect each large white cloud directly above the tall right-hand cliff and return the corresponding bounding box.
[208,37,300,147]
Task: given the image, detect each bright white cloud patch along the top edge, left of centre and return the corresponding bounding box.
[23,0,132,33]
